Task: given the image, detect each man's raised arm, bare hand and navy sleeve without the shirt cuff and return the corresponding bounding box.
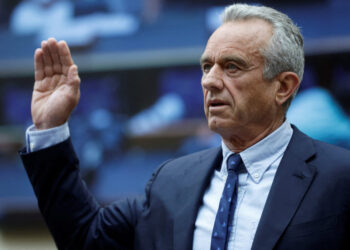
[21,39,141,249]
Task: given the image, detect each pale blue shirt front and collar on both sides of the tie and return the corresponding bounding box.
[193,121,293,250]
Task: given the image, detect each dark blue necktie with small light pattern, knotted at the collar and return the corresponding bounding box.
[210,154,242,250]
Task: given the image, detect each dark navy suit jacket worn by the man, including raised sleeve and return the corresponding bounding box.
[21,127,350,250]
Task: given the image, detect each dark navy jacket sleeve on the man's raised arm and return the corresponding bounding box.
[20,139,142,250]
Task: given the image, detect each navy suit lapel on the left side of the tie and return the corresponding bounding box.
[174,148,222,250]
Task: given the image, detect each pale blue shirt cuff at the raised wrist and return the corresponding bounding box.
[26,122,70,153]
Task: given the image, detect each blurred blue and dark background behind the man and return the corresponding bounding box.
[0,0,350,250]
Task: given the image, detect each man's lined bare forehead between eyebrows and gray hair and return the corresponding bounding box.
[203,19,273,62]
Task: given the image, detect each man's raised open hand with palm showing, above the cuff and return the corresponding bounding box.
[31,38,80,130]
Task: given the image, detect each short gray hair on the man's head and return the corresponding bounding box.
[222,4,305,107]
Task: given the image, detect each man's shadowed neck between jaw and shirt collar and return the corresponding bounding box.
[222,118,284,153]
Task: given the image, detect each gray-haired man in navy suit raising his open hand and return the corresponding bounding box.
[21,4,350,250]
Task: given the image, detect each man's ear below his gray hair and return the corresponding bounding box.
[276,72,300,106]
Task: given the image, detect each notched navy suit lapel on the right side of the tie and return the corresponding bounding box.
[252,127,316,250]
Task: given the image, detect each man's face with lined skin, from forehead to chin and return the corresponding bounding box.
[201,19,277,138]
